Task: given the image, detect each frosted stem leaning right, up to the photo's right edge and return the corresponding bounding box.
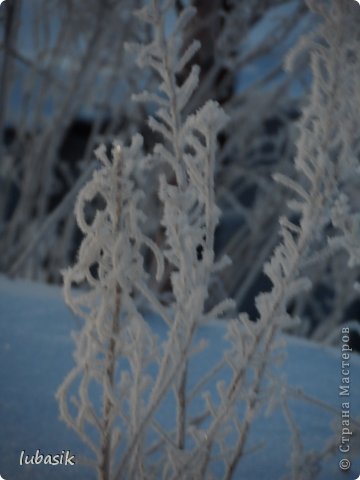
[189,0,360,472]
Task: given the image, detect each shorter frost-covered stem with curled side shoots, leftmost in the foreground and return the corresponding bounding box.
[57,137,163,480]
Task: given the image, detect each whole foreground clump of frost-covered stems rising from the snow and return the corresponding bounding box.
[58,0,360,480]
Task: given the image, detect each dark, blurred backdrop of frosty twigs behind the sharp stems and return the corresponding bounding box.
[0,0,360,348]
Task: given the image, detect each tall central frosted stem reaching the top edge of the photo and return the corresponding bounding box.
[121,1,233,475]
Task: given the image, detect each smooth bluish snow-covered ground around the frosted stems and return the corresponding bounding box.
[0,277,360,480]
